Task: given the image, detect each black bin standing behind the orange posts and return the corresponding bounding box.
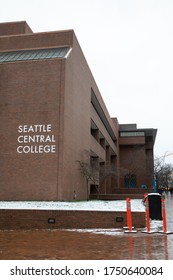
[143,193,162,220]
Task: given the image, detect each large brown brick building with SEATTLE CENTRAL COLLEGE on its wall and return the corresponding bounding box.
[0,22,156,200]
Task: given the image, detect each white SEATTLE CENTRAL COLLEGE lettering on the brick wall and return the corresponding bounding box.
[17,124,56,154]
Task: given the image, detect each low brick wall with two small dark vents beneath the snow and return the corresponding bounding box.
[0,209,145,230]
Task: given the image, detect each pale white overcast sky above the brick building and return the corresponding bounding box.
[0,0,173,163]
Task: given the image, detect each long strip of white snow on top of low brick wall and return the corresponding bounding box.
[0,199,145,212]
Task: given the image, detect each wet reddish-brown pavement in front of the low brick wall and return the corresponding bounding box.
[0,194,173,260]
